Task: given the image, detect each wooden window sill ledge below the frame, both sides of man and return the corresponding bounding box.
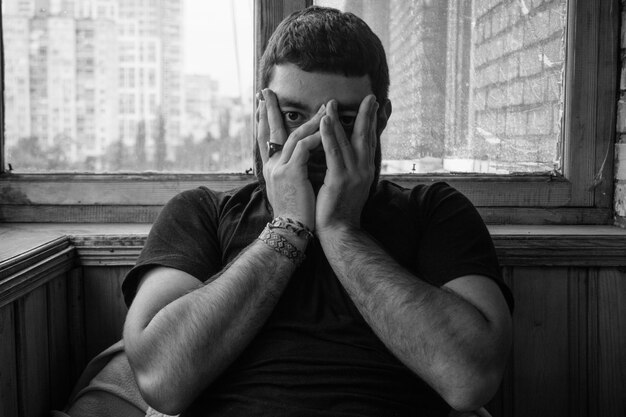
[0,223,626,274]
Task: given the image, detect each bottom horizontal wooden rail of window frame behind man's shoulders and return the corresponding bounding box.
[0,173,614,225]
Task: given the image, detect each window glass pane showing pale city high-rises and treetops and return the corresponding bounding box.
[2,0,254,172]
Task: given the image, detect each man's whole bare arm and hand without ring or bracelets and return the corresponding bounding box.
[315,97,511,410]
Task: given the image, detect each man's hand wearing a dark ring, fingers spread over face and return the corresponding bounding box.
[257,89,324,230]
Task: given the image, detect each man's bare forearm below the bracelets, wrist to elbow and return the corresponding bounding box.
[125,234,302,414]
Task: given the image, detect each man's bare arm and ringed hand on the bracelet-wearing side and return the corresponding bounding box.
[124,90,323,414]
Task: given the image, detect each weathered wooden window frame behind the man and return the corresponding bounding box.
[0,0,620,224]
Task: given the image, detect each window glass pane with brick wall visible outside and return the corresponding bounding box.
[315,0,567,174]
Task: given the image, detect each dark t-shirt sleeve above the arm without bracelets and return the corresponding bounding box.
[411,183,513,310]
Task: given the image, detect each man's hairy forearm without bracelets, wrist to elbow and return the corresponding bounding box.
[320,229,506,406]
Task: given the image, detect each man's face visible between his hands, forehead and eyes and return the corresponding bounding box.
[268,64,372,189]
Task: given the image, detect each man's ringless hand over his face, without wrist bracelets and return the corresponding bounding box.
[315,95,378,234]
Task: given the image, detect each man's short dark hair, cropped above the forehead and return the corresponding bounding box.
[259,6,389,103]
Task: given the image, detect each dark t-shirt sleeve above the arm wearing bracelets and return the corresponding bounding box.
[122,188,222,306]
